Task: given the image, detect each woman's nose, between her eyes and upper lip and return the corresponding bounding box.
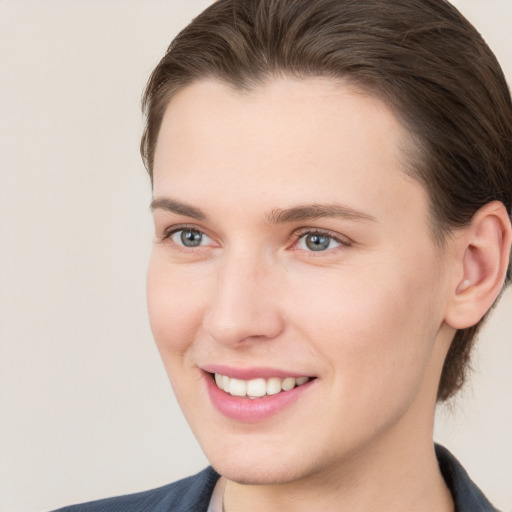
[203,255,284,347]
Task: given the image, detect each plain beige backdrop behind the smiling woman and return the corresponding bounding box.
[0,0,512,512]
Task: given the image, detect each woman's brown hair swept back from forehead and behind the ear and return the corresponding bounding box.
[141,0,512,401]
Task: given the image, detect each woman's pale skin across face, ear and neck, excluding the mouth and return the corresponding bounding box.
[148,78,511,512]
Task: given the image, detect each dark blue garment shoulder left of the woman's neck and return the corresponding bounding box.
[55,467,219,512]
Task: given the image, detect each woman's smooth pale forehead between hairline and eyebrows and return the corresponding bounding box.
[154,78,426,231]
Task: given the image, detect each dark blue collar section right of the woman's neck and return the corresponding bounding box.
[435,444,498,512]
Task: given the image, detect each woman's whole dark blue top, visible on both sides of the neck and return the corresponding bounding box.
[55,445,497,512]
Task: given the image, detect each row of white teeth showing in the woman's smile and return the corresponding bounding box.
[211,373,310,398]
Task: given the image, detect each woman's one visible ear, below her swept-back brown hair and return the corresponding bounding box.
[445,201,512,329]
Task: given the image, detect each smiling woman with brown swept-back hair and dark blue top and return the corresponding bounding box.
[54,0,512,512]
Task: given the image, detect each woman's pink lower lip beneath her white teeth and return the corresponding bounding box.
[205,374,316,423]
